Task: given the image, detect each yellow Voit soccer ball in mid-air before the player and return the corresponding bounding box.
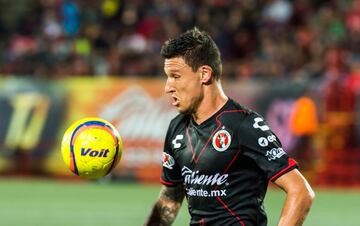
[61,117,122,179]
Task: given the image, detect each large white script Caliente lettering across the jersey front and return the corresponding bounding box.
[181,166,229,185]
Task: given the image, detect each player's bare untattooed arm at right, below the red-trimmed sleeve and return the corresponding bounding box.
[274,169,315,226]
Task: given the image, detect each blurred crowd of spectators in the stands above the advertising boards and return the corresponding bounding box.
[0,0,360,81]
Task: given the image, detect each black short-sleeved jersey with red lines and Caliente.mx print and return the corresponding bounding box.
[161,99,297,226]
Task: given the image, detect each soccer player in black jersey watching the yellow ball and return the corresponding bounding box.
[145,28,314,226]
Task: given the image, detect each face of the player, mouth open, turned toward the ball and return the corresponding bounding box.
[164,57,203,114]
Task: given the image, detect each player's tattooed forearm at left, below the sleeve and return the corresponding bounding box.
[145,184,185,226]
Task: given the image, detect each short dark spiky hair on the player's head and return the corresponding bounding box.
[160,27,222,80]
